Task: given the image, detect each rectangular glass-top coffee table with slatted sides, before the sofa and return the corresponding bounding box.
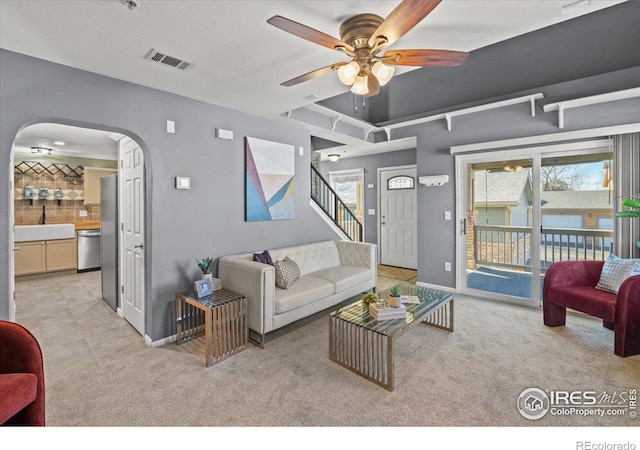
[329,284,453,391]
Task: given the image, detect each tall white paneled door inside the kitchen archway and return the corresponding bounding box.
[119,138,145,336]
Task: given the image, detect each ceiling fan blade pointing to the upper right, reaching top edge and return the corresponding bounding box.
[369,0,442,48]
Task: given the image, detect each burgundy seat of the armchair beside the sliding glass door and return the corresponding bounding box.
[548,286,616,322]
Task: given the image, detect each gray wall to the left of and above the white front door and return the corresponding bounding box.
[321,149,416,244]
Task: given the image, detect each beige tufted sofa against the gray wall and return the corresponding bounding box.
[218,241,376,344]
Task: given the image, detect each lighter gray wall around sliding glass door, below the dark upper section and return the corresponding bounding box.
[393,67,640,287]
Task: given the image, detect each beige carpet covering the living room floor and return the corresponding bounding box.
[42,296,640,427]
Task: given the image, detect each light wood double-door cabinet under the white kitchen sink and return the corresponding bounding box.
[13,239,78,277]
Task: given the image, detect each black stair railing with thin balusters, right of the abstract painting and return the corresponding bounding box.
[311,165,363,242]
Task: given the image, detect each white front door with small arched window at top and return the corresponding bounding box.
[378,166,418,269]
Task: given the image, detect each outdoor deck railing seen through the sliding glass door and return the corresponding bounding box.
[474,225,613,271]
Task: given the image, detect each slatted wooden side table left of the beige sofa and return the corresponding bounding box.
[176,289,249,367]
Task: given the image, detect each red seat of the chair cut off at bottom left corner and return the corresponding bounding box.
[0,373,38,424]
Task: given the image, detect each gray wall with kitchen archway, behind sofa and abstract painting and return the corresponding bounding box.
[0,50,335,340]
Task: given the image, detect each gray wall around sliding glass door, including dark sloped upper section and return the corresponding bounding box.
[325,1,640,287]
